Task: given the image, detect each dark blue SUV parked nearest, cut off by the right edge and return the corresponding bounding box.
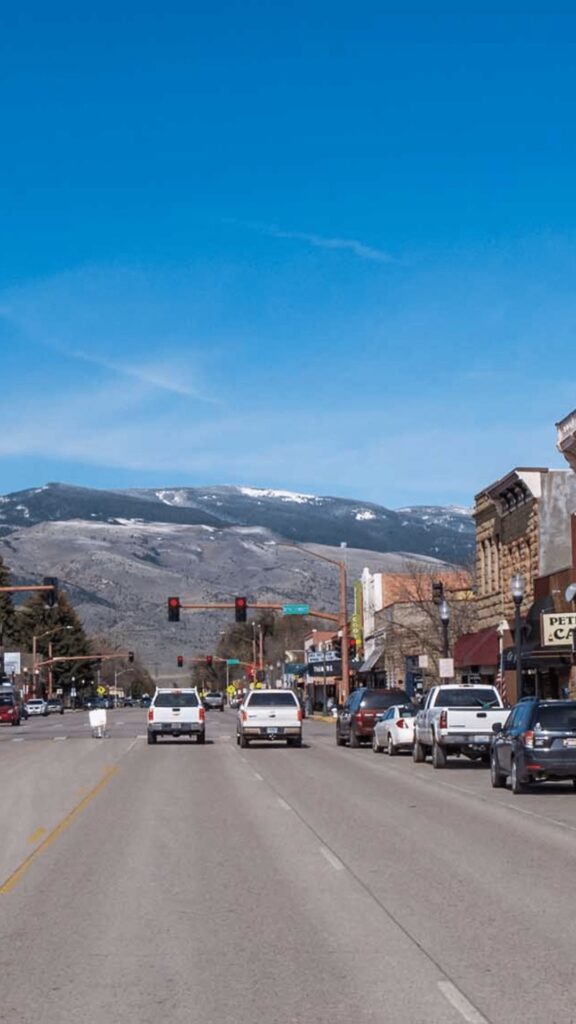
[490,697,576,793]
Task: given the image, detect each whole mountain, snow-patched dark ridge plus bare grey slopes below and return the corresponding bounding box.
[0,483,474,673]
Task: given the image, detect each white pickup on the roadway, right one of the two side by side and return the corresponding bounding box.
[236,689,302,746]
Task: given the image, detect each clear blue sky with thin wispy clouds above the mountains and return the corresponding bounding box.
[0,0,576,507]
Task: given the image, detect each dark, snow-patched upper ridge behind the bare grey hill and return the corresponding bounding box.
[0,483,475,564]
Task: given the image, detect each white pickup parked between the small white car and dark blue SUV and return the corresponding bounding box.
[413,683,504,768]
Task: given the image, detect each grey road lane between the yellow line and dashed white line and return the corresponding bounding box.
[0,726,462,1024]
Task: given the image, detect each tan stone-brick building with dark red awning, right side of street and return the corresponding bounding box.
[455,467,576,699]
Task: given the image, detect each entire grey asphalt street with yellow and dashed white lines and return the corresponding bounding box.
[0,709,576,1024]
